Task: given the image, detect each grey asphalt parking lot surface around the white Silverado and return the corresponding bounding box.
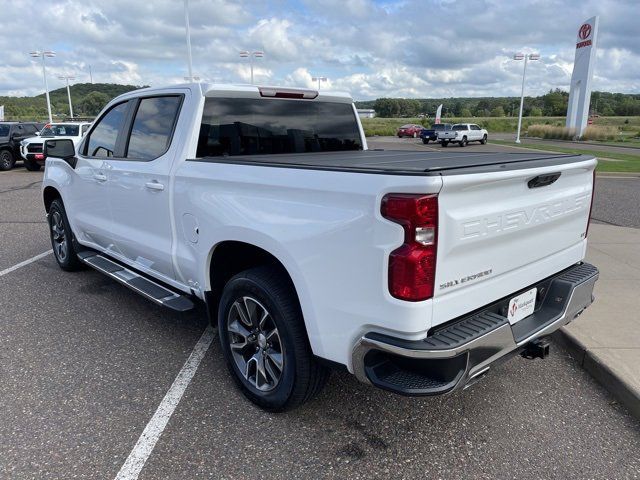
[0,154,640,479]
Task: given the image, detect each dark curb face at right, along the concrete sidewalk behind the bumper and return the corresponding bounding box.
[552,328,640,420]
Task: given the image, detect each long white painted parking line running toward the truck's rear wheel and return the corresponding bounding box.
[116,326,216,480]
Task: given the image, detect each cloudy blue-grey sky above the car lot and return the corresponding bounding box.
[0,0,640,99]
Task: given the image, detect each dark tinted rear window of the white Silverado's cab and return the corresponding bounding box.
[196,98,362,157]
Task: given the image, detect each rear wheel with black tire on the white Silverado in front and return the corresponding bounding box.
[218,265,330,412]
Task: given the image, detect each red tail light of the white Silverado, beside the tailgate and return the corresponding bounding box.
[380,193,438,302]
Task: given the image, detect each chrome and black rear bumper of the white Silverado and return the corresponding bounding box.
[352,263,598,396]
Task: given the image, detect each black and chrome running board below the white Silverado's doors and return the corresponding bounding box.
[78,250,195,312]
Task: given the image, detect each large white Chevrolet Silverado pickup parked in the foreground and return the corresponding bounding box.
[43,84,598,411]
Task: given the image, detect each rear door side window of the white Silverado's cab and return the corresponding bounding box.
[126,95,182,160]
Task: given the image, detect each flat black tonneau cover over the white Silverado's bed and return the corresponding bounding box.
[189,150,593,176]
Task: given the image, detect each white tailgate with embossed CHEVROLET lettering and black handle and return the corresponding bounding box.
[433,159,597,325]
